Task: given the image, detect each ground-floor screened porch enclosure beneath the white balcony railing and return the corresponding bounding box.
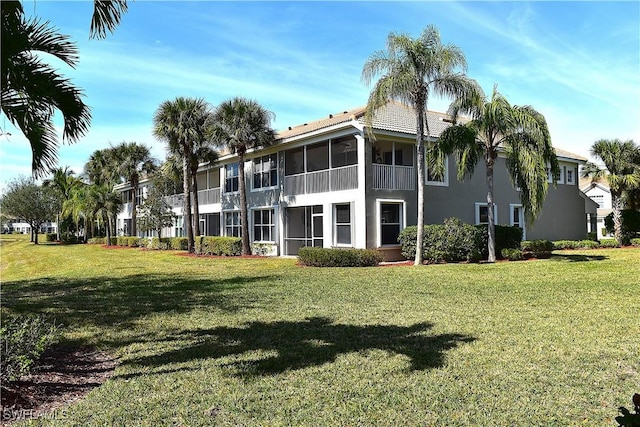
[284,205,324,255]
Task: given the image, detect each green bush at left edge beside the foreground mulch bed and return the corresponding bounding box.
[0,315,60,383]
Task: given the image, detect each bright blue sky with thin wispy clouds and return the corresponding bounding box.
[0,0,640,191]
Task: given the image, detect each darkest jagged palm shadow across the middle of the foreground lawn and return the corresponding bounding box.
[125,317,475,378]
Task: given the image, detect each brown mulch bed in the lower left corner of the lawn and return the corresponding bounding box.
[0,345,118,425]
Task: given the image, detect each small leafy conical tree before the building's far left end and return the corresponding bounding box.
[138,173,177,238]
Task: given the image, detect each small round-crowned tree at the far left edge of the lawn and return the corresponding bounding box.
[0,177,60,245]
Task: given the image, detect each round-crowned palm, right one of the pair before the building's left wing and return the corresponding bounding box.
[212,97,275,255]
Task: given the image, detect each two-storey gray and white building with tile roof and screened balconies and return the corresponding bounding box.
[118,103,586,259]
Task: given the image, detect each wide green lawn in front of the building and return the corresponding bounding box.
[0,236,640,426]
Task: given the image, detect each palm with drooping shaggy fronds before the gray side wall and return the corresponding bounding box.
[432,86,560,262]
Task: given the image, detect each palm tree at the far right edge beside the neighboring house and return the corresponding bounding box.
[582,139,640,245]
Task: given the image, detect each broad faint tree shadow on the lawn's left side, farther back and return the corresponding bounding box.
[2,274,273,328]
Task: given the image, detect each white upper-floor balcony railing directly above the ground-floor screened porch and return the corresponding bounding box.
[284,165,358,196]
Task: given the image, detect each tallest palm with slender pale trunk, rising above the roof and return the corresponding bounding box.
[362,25,478,265]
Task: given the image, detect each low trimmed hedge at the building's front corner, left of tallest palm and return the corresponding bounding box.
[298,247,383,267]
